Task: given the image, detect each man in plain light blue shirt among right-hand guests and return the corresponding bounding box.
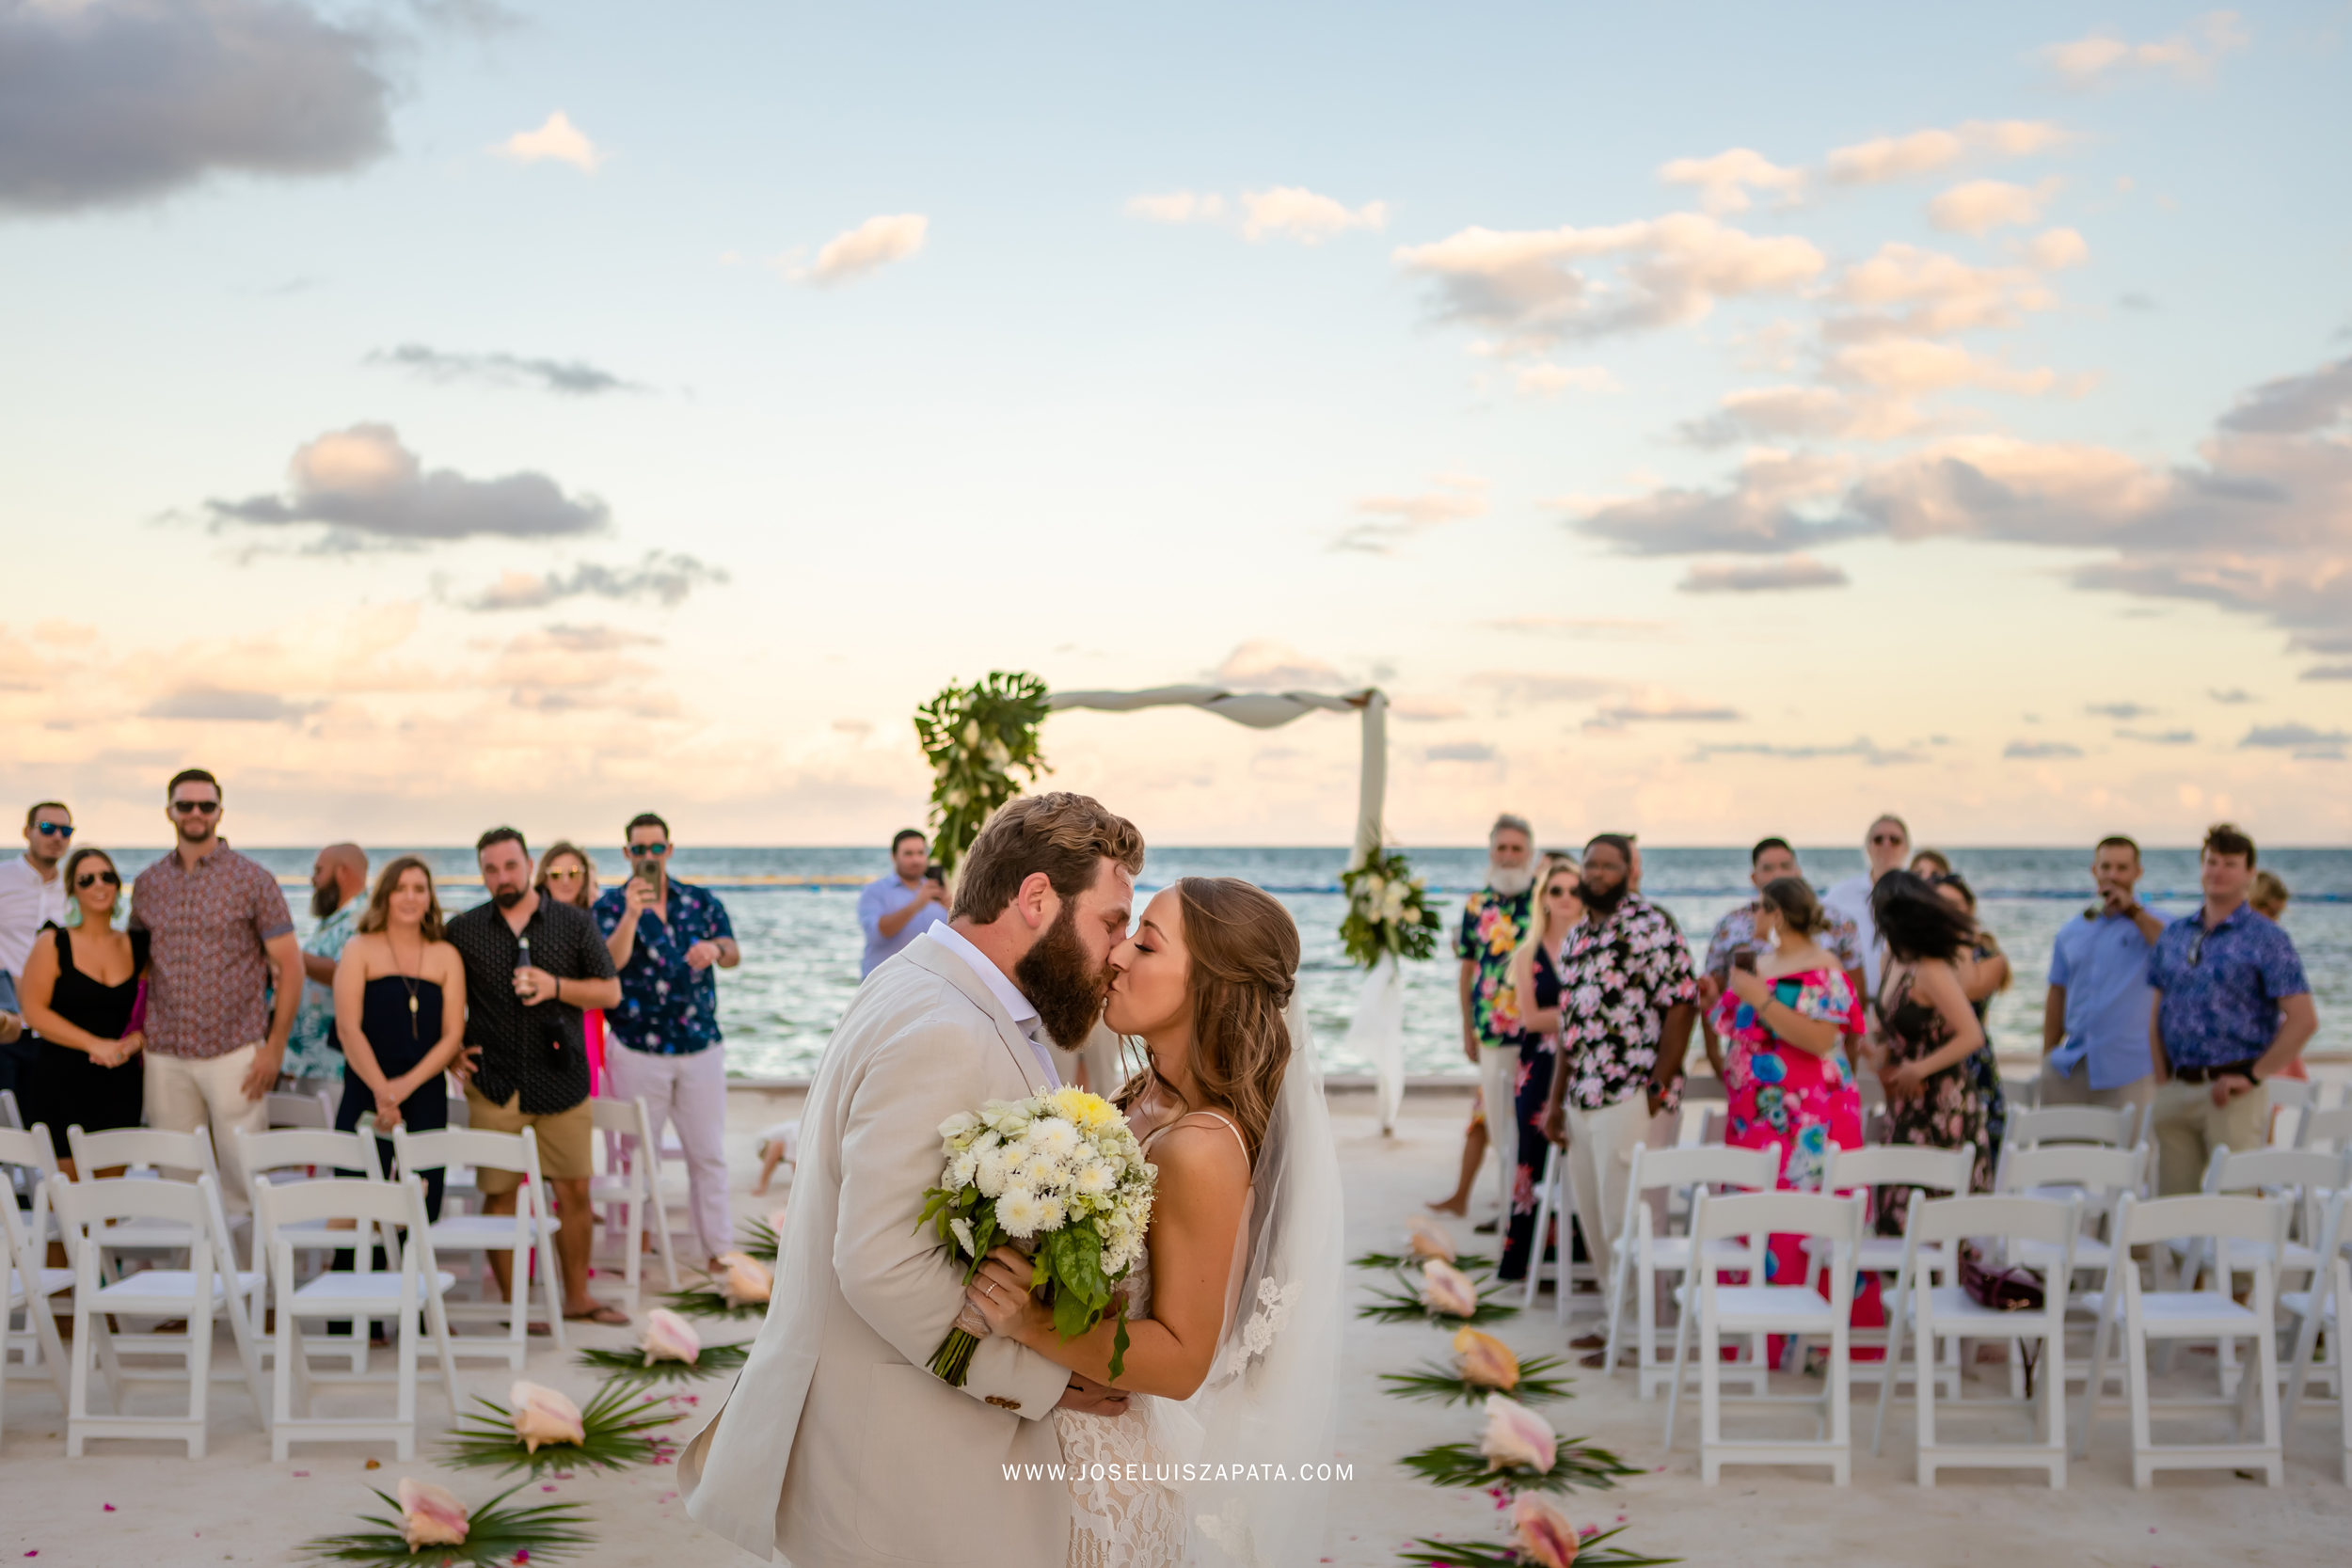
[2042,834,2164,1115]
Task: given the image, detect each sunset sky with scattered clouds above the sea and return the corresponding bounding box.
[0,0,2352,844]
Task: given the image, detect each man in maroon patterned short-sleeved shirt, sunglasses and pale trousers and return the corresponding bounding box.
[132,768,304,1213]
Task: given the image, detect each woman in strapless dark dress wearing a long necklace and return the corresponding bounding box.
[334,856,466,1220]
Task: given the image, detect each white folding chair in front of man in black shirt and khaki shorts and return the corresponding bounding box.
[393,1126,564,1373]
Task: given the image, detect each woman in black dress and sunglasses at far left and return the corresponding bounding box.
[22,848,149,1176]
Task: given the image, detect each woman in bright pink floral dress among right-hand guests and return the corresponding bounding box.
[1712,877,1884,1328]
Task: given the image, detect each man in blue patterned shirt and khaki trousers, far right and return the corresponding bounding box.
[2148,823,2319,1196]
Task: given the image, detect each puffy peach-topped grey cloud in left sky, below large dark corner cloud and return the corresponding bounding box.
[205,423,610,550]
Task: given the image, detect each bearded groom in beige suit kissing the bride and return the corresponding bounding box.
[677,795,1143,1568]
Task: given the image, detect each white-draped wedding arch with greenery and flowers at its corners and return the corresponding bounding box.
[915,670,1438,1133]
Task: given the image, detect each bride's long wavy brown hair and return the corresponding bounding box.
[1118,877,1298,1164]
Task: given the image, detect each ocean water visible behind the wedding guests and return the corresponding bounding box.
[105,847,2352,1079]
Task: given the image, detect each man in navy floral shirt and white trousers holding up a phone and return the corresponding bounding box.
[596,811,743,1260]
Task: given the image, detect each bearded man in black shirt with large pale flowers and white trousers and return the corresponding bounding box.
[1546,832,1698,1366]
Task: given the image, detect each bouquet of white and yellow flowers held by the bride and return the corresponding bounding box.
[915,1088,1160,1387]
